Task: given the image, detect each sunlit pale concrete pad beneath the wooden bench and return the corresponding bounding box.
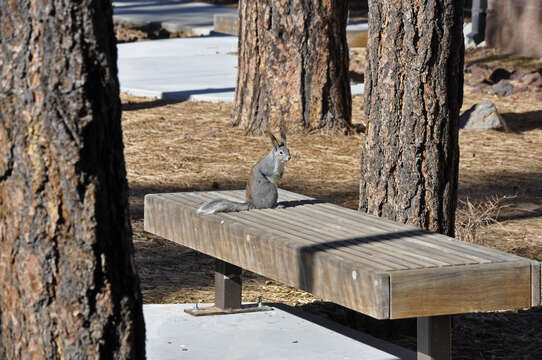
[143,304,416,360]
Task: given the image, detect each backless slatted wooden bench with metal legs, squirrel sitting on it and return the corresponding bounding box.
[145,190,540,359]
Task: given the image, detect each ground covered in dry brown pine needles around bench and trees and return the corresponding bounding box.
[122,49,542,359]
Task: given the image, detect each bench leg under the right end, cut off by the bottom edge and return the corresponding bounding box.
[418,315,452,360]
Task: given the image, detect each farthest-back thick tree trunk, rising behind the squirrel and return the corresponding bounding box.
[232,0,352,134]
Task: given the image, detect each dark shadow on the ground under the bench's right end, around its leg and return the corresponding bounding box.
[301,301,542,359]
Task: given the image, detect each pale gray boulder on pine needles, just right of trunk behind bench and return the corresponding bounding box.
[459,101,507,130]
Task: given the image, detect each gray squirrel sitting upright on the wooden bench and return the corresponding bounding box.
[197,124,290,215]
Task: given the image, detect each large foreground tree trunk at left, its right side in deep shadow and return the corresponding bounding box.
[0,0,145,359]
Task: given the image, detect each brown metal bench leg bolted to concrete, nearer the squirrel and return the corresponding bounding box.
[215,259,241,310]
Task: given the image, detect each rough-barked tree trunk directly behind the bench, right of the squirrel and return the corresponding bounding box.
[360,0,464,236]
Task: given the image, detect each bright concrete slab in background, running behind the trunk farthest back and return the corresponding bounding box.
[118,36,363,102]
